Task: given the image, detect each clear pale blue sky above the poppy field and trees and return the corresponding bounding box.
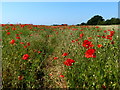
[2,2,118,25]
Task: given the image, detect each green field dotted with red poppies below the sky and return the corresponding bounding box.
[0,24,120,89]
